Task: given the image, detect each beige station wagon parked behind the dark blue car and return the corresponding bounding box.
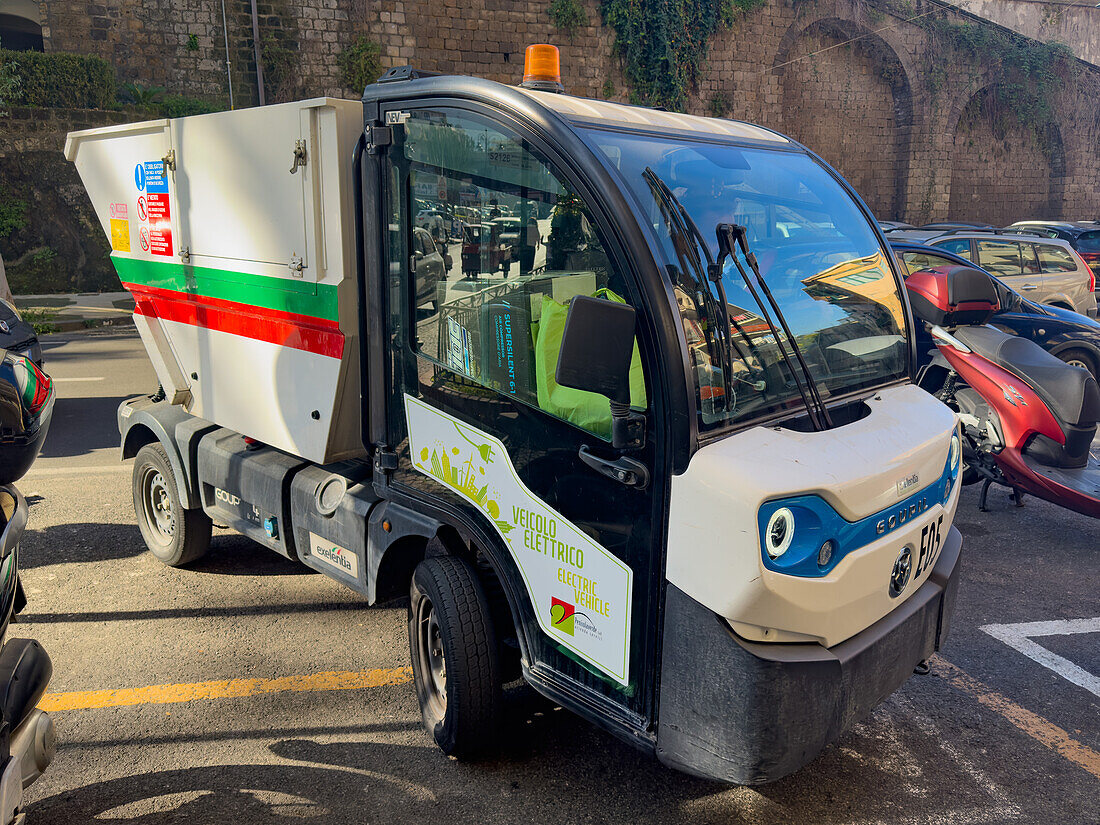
[890,229,1097,317]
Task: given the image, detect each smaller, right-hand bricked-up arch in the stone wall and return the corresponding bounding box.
[948,84,1066,226]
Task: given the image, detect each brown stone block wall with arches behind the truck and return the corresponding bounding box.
[25,0,1100,229]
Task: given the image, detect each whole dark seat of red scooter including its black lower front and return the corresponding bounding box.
[954,327,1100,468]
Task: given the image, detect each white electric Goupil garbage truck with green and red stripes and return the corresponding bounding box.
[65,48,961,784]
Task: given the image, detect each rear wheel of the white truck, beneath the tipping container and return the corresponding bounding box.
[133,442,211,568]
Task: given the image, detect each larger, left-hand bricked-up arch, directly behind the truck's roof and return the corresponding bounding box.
[772,17,914,219]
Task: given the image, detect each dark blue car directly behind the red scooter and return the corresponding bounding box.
[890,242,1100,376]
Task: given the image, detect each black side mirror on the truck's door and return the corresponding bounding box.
[556,295,635,407]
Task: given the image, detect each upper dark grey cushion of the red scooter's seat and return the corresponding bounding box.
[954,327,1100,435]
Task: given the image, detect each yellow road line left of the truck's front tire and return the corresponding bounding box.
[39,668,413,712]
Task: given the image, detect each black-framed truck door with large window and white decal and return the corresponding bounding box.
[374,105,667,727]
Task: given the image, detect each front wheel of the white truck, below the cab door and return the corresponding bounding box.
[408,557,502,759]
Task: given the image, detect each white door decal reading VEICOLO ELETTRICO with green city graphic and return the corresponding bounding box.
[405,395,634,684]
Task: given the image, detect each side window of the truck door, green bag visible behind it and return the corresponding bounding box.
[391,114,647,439]
